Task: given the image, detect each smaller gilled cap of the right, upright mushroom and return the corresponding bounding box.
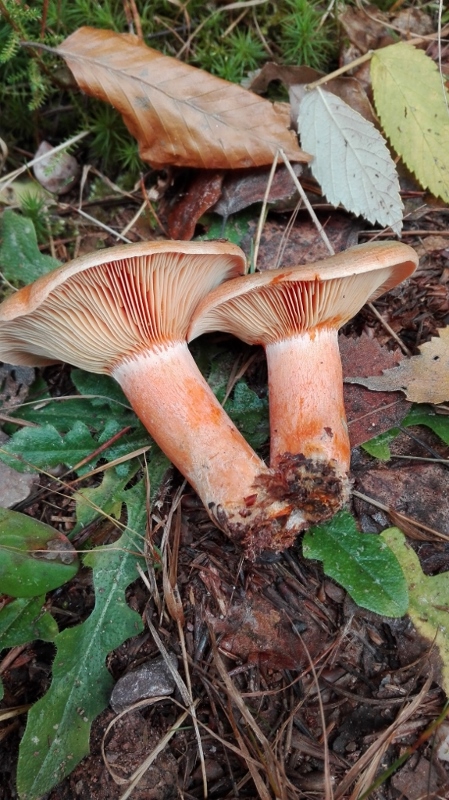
[188,241,418,345]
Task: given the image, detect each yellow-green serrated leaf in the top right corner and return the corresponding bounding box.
[371,42,449,202]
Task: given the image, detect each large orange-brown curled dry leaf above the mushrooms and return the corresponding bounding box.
[58,27,309,169]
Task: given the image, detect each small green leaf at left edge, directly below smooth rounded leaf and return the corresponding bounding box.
[0,595,58,650]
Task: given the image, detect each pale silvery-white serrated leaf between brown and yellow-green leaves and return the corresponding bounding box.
[298,88,403,234]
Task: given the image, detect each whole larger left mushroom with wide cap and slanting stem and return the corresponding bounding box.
[0,241,302,555]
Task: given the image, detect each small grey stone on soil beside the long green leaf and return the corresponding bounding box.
[110,653,178,714]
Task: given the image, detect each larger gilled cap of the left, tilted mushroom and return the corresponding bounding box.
[0,241,246,373]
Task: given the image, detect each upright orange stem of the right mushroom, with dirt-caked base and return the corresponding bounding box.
[266,327,351,522]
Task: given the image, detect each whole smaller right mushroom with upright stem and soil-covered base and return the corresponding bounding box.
[187,241,418,527]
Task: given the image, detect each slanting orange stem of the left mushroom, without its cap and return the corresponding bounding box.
[111,342,294,549]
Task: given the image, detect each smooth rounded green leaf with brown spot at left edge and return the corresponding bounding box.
[0,508,79,597]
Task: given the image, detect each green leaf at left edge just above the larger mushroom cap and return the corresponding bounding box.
[0,209,59,284]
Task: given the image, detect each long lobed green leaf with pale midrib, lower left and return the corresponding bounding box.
[17,482,146,800]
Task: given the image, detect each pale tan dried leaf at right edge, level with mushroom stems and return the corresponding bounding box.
[346,327,449,403]
